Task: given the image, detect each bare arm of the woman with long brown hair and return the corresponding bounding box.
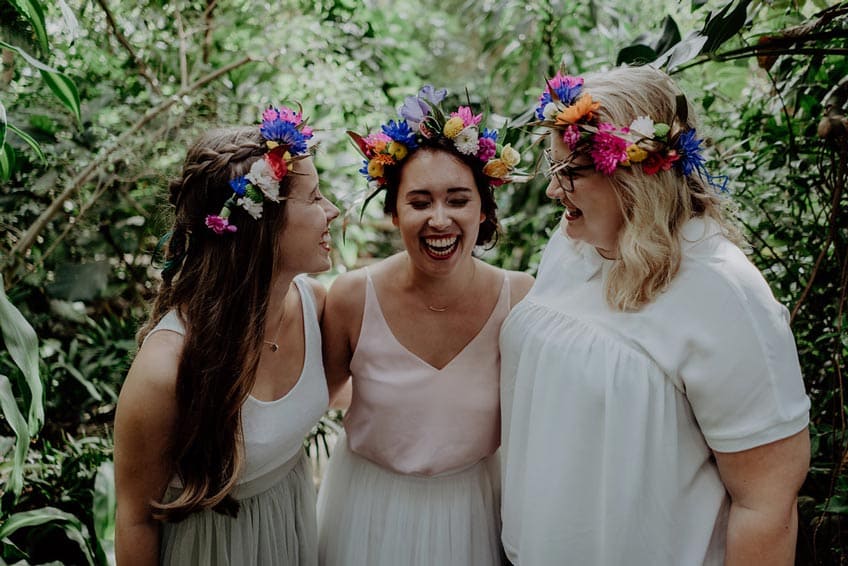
[115,331,182,566]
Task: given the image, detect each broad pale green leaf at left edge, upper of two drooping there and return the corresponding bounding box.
[0,275,44,440]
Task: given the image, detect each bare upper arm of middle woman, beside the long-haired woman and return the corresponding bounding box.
[321,272,365,409]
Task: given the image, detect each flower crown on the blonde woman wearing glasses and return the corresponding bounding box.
[536,72,724,182]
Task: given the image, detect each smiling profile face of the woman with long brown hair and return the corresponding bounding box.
[279,158,339,273]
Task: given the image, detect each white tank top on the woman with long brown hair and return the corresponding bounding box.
[145,275,329,487]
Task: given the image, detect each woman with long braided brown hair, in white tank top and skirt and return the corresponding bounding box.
[115,107,338,566]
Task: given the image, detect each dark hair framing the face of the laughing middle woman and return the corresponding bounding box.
[383,136,499,246]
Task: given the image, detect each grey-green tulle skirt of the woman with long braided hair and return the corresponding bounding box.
[160,452,318,566]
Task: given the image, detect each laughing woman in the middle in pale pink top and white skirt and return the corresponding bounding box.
[318,87,532,566]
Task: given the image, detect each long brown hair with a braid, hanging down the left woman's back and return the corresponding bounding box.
[138,127,290,521]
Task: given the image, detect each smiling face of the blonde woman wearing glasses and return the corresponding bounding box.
[545,131,624,258]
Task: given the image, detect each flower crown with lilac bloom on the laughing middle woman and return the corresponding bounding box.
[347,85,521,202]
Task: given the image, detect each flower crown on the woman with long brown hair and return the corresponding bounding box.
[206,106,312,235]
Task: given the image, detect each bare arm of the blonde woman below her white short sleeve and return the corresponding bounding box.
[715,429,810,566]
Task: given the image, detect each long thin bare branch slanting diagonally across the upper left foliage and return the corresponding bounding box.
[4,57,255,280]
